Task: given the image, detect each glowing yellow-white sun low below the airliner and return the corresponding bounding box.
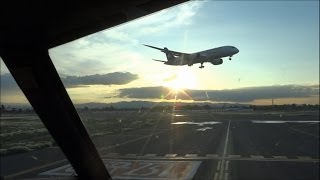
[164,69,197,92]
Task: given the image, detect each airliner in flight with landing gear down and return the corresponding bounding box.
[144,44,239,68]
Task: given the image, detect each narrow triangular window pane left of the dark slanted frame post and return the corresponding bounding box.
[0,59,67,179]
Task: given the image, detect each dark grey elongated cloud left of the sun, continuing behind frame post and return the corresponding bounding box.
[1,72,139,92]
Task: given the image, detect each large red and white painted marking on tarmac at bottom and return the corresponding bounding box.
[39,159,201,180]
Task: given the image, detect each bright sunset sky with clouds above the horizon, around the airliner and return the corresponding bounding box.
[1,1,319,104]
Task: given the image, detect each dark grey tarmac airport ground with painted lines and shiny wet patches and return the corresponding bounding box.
[1,111,319,180]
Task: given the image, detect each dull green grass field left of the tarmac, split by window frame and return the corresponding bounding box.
[0,112,160,156]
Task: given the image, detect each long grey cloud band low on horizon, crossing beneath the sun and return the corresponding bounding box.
[118,85,319,103]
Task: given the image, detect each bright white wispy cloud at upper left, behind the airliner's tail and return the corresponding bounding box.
[49,1,203,75]
